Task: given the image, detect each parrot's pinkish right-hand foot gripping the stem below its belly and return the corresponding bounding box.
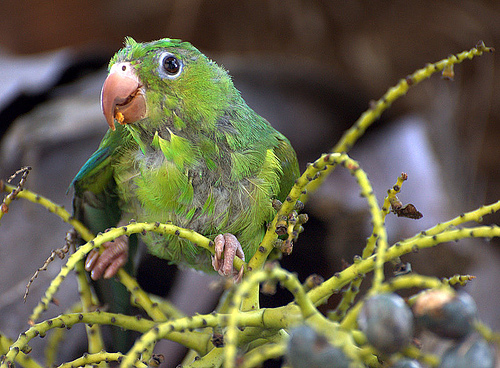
[212,233,245,282]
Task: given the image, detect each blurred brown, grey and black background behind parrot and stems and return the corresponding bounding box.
[0,0,500,367]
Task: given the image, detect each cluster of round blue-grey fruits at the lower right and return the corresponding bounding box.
[287,289,495,368]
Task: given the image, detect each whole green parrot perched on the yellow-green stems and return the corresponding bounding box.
[71,38,299,280]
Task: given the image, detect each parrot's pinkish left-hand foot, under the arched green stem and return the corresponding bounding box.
[85,235,128,281]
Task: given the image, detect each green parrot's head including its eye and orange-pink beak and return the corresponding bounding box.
[101,37,233,130]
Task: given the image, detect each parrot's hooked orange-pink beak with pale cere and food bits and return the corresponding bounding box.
[101,62,147,130]
